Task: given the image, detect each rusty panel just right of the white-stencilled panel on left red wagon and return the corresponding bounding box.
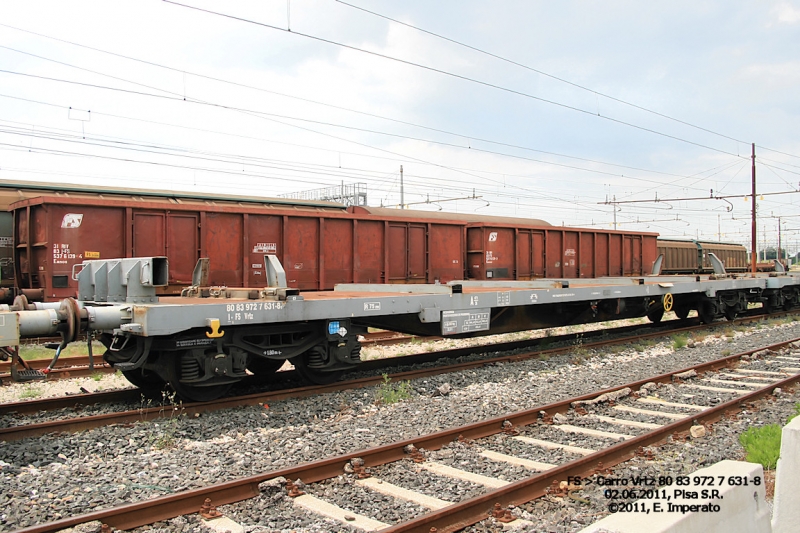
[283,217,318,290]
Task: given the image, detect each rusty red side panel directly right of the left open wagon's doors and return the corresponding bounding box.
[205,212,242,287]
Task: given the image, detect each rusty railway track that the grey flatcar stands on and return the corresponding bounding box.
[0,317,788,441]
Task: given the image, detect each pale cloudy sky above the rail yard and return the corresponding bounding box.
[0,0,800,253]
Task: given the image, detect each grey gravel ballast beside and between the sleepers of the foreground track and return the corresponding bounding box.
[0,321,800,532]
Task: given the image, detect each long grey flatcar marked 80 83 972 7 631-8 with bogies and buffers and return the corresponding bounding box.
[0,258,800,399]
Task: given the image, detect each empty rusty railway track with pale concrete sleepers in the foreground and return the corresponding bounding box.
[14,339,800,533]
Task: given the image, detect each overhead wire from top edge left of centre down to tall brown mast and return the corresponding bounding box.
[162,0,752,157]
